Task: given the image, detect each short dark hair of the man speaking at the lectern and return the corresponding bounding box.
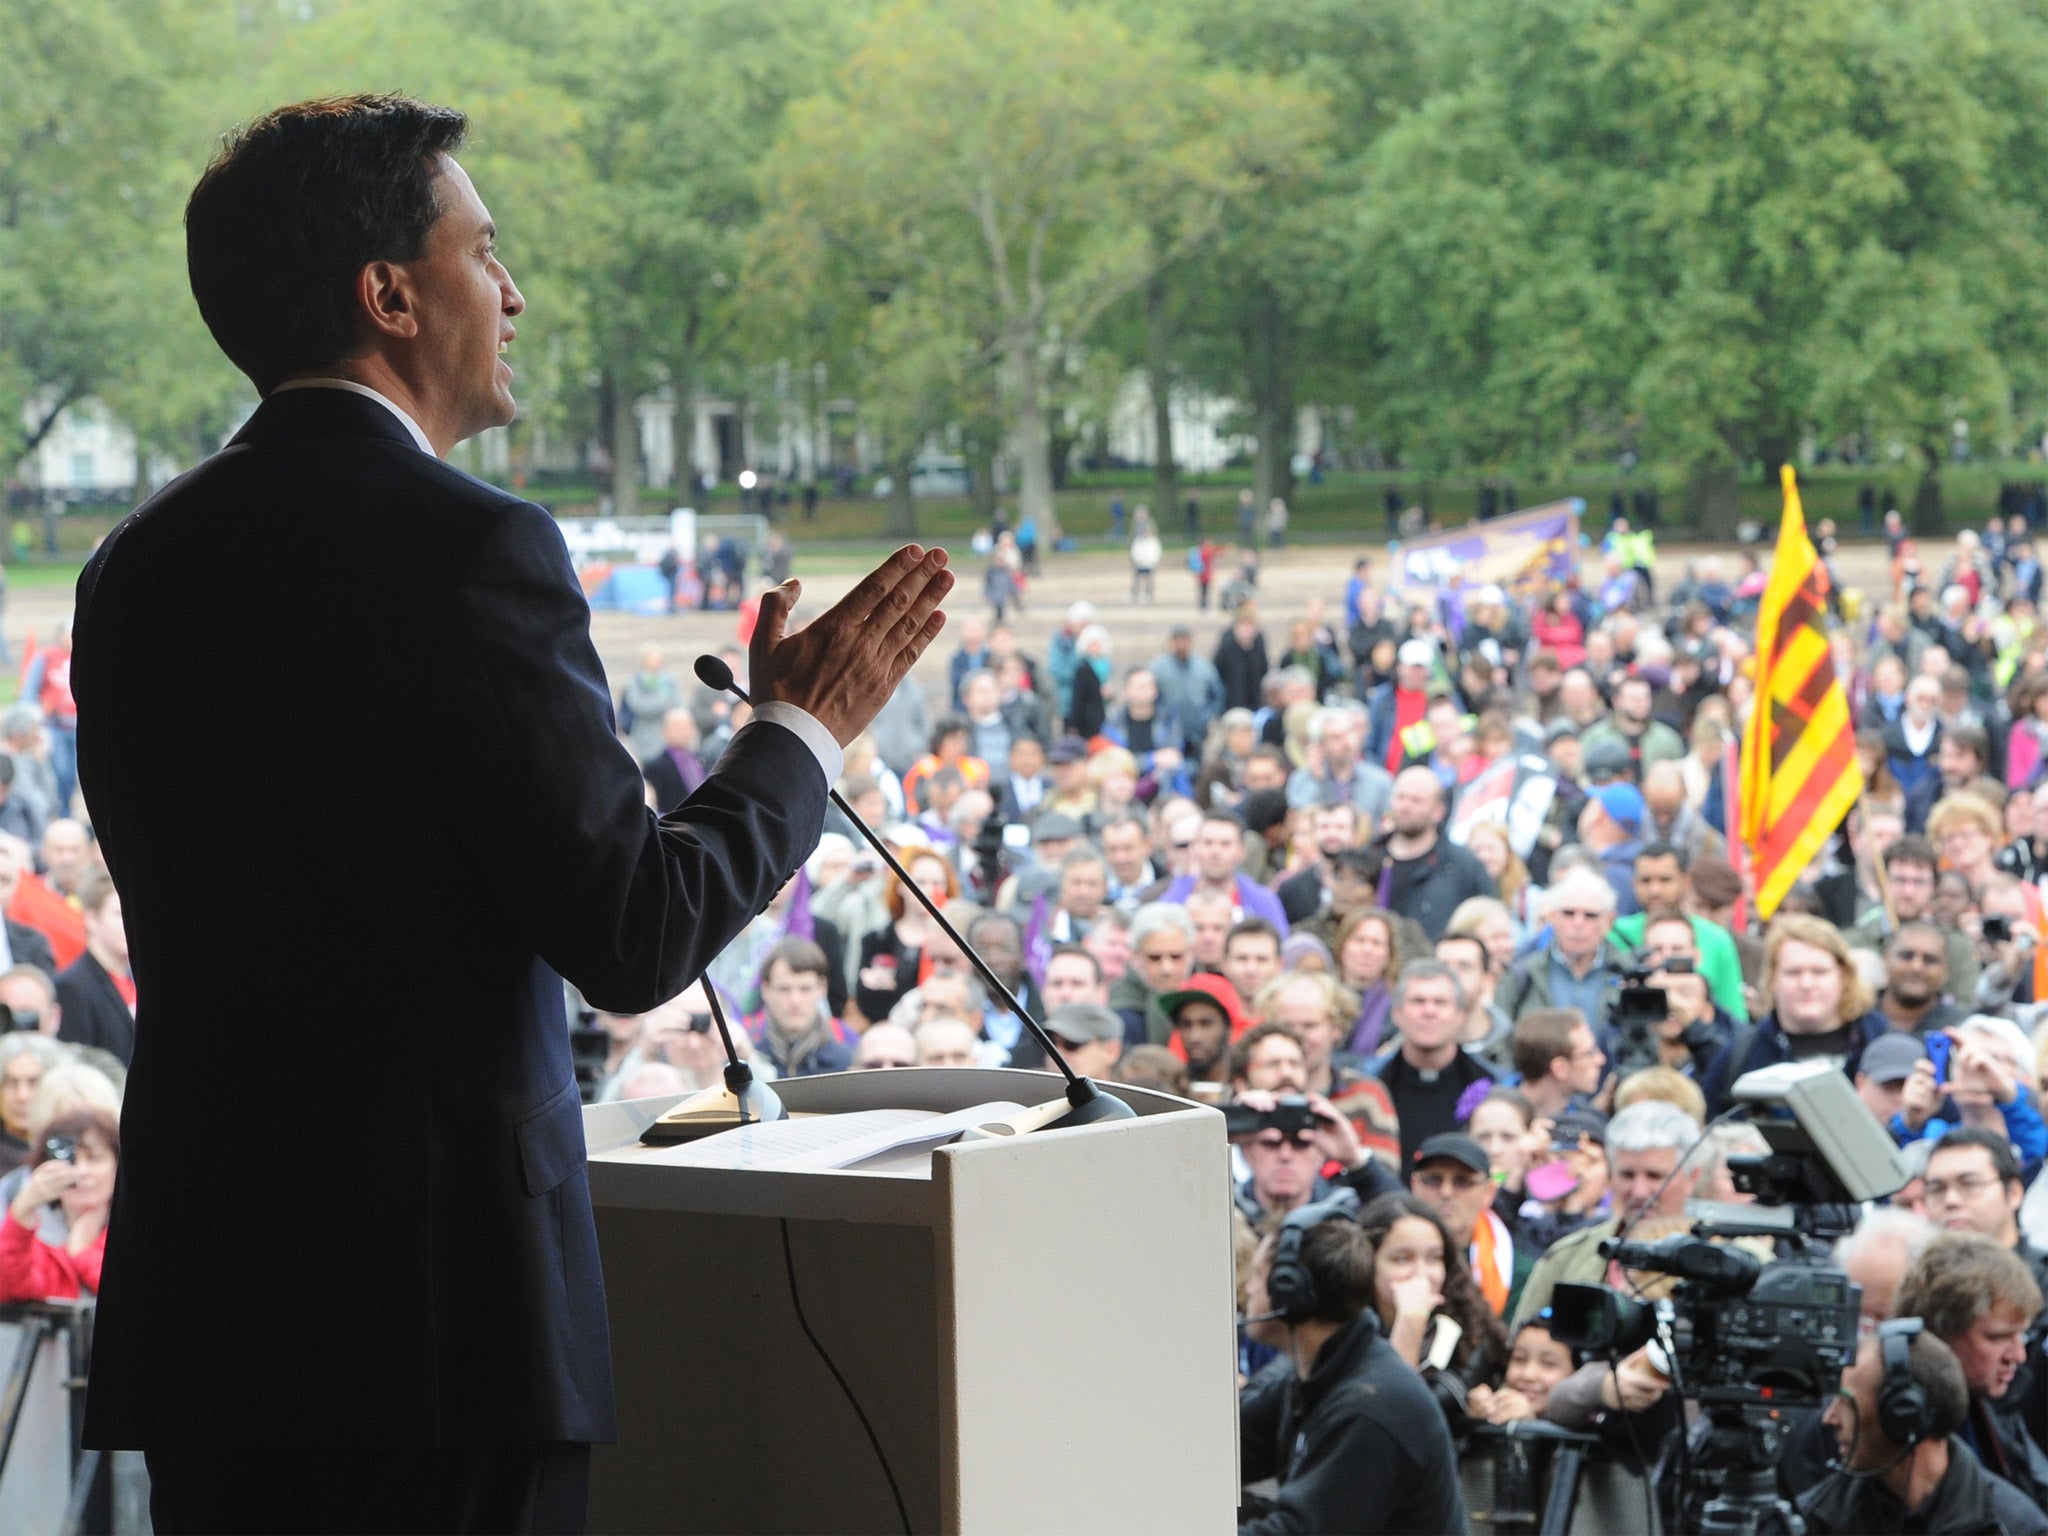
[184,96,469,395]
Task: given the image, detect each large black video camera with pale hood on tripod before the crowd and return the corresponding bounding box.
[1550,1061,1907,1532]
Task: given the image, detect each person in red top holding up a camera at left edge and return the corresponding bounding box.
[0,1108,121,1300]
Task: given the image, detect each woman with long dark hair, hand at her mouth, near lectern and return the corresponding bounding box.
[1358,1194,1507,1432]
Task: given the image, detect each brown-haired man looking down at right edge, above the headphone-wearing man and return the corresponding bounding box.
[1892,1231,2048,1505]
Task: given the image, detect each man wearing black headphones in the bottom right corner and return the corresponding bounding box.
[1798,1317,2048,1536]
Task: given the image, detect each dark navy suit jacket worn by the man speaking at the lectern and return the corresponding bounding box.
[72,389,825,1448]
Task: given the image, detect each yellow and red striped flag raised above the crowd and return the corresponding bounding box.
[1737,465,1864,920]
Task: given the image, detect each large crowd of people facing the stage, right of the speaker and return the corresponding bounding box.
[598,516,2048,1532]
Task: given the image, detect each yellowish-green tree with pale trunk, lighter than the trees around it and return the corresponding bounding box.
[768,0,1237,530]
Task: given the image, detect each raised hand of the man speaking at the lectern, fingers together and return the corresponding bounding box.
[748,545,952,745]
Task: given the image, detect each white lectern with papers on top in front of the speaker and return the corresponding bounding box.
[584,1069,1239,1532]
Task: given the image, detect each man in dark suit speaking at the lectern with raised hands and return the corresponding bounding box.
[74,98,952,1532]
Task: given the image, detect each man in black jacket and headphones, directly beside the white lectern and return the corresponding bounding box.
[1237,1210,1466,1536]
